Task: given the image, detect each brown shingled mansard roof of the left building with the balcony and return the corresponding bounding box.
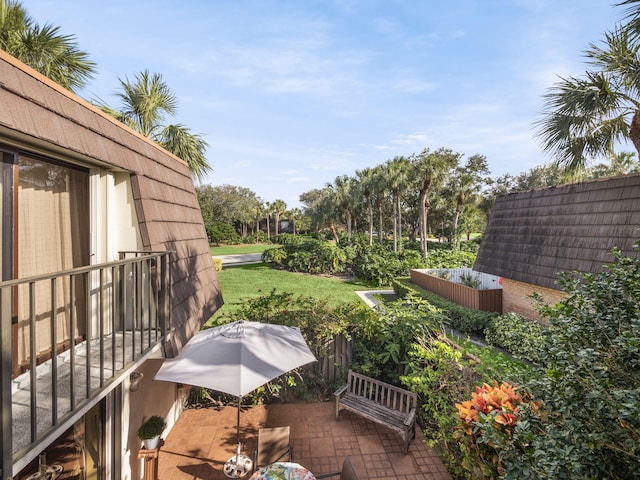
[0,50,222,348]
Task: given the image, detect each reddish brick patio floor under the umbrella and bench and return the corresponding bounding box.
[158,402,451,480]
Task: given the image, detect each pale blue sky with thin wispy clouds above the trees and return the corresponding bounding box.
[22,0,625,208]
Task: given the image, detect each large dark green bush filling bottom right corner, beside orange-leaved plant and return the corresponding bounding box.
[462,250,640,479]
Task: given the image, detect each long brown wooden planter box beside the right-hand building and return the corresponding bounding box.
[411,270,502,313]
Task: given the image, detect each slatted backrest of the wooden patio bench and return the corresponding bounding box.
[347,370,418,414]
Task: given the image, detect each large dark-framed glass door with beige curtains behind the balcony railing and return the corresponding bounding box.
[0,149,90,374]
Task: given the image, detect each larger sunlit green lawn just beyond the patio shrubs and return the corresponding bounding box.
[213,263,369,324]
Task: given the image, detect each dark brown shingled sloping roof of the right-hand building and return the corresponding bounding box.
[474,175,640,289]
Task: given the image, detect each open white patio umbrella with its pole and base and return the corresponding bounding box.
[154,320,316,478]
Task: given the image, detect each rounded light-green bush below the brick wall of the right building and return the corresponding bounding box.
[484,313,548,364]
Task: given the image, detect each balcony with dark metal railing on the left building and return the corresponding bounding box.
[0,252,172,477]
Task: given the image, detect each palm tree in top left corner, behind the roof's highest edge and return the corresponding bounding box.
[0,0,96,91]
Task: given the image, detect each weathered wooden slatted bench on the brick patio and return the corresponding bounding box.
[334,370,418,453]
